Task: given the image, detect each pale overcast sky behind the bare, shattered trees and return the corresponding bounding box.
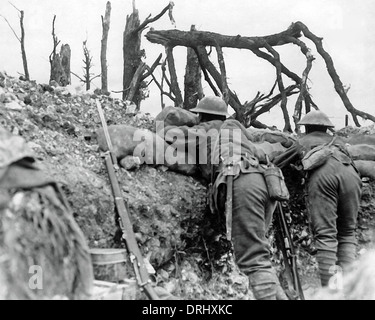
[0,0,375,129]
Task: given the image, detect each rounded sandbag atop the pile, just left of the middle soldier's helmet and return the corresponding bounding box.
[155,106,198,132]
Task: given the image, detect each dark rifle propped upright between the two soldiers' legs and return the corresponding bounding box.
[275,201,305,300]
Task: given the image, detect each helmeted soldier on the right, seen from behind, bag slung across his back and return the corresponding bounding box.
[273,110,362,286]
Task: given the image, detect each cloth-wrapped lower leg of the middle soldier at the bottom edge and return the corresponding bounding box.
[249,270,276,300]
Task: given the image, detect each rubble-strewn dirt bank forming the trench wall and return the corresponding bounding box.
[0,74,375,300]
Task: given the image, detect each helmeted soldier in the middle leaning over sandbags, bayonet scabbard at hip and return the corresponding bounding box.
[157,96,287,300]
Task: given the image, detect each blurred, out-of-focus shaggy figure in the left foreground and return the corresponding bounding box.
[0,128,94,300]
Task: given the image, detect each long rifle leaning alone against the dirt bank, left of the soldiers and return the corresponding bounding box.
[96,100,159,300]
